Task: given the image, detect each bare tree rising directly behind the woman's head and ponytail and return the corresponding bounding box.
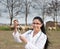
[33,0,47,21]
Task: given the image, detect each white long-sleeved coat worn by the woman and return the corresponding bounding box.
[13,30,47,49]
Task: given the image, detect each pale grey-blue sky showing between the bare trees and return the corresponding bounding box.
[0,0,60,24]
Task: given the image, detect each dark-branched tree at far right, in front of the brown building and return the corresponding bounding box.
[47,0,60,27]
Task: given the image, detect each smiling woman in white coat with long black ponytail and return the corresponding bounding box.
[13,17,48,49]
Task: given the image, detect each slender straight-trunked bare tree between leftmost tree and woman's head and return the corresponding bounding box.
[19,0,32,25]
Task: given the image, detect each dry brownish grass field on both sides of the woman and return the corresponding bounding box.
[0,31,60,49]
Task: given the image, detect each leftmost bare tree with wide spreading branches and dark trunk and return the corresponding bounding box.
[0,0,22,25]
